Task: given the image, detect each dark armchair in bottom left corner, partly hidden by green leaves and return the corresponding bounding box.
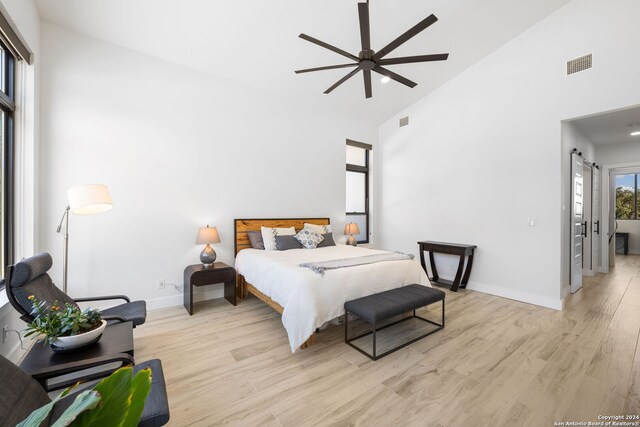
[0,356,169,427]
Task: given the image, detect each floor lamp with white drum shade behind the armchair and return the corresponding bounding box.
[56,184,113,294]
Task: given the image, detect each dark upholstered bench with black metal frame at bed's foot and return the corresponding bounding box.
[344,285,445,360]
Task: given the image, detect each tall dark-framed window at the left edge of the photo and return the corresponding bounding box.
[0,41,16,278]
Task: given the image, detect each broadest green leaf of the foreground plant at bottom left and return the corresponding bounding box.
[73,367,133,427]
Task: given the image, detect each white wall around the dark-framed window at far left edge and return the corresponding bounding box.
[0,0,40,361]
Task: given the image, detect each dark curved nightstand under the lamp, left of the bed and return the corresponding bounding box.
[183,262,236,314]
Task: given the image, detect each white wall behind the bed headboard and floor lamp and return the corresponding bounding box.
[39,24,377,307]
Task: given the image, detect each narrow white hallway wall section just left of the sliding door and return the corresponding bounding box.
[560,122,595,297]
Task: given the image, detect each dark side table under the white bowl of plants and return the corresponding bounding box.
[20,322,134,391]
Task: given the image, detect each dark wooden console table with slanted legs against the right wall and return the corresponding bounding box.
[418,241,477,292]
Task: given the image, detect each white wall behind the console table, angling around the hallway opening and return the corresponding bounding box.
[377,0,640,308]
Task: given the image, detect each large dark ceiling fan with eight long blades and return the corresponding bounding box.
[296,1,449,98]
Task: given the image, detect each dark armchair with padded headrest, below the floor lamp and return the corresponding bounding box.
[5,253,147,328]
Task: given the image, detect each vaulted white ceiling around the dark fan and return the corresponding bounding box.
[37,0,569,124]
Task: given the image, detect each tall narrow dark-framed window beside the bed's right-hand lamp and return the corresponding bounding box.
[346,140,372,243]
